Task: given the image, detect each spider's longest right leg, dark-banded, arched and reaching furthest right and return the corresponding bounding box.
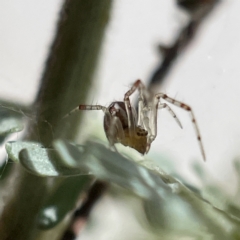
[154,93,206,160]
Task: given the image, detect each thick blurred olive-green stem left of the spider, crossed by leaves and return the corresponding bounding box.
[0,0,111,240]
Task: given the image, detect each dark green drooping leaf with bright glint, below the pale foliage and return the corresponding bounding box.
[37,176,90,230]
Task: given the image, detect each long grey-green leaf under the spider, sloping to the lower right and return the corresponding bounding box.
[54,140,240,240]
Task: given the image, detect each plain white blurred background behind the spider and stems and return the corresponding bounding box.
[0,0,240,239]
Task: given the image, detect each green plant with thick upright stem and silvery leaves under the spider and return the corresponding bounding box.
[0,0,240,240]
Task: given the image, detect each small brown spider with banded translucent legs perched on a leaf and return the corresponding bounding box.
[66,80,205,160]
